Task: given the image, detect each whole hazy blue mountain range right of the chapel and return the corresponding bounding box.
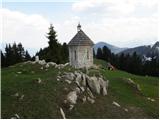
[93,41,159,57]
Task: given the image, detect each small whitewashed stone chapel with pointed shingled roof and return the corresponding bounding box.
[68,24,94,68]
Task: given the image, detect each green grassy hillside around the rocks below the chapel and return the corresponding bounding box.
[1,60,159,118]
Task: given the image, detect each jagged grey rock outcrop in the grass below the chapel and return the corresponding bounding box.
[57,71,109,117]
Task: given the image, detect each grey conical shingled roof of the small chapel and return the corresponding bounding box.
[68,25,94,46]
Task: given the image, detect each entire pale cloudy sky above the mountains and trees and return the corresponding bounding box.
[0,0,159,54]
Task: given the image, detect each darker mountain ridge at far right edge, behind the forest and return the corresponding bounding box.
[119,41,159,57]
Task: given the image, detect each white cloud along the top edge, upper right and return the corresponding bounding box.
[72,0,158,15]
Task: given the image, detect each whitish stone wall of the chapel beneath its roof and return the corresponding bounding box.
[69,46,93,68]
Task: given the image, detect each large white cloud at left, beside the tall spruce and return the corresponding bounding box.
[0,8,50,52]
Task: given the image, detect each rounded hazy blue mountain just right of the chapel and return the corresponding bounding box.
[93,42,127,54]
